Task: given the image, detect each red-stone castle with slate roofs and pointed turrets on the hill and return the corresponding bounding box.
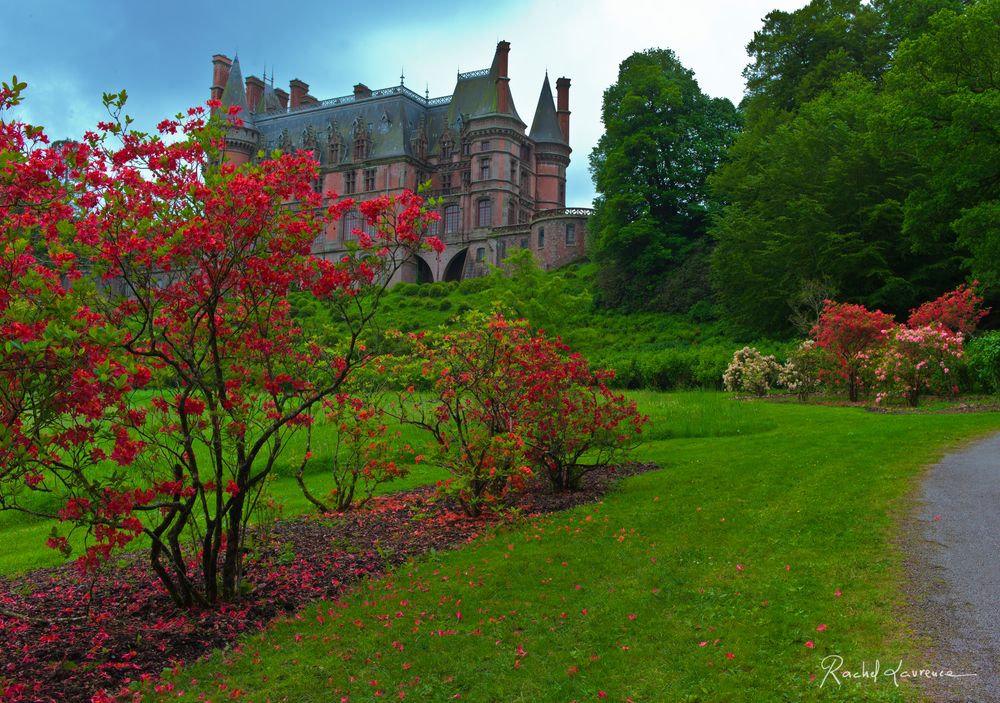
[211,41,590,282]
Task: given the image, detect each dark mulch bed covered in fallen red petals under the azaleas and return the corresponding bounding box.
[0,463,659,703]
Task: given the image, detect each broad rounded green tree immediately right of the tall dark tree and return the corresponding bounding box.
[713,76,936,333]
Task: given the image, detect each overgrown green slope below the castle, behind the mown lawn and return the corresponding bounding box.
[293,253,795,390]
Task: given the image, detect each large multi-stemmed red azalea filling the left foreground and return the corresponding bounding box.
[0,82,441,605]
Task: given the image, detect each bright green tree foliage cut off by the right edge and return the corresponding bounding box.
[883,0,1000,288]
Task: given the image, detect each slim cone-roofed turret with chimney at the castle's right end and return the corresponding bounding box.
[529,73,572,210]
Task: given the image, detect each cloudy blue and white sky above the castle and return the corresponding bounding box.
[0,0,805,206]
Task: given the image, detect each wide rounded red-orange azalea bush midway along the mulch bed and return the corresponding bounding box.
[398,312,646,516]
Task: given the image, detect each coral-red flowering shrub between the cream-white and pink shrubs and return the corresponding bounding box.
[812,300,896,402]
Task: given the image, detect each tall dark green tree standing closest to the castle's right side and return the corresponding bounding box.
[590,49,739,310]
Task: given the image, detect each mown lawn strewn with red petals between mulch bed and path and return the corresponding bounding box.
[129,393,1000,703]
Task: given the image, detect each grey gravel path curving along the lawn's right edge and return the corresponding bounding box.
[907,434,1000,703]
